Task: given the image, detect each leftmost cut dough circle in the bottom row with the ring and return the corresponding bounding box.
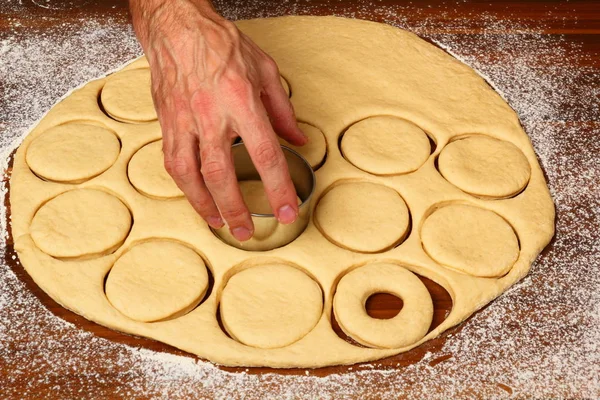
[105,240,208,322]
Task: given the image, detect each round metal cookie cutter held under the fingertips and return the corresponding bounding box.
[213,142,316,251]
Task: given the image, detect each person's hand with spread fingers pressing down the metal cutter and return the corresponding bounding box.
[130,0,307,241]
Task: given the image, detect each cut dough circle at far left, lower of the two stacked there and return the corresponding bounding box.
[30,189,131,258]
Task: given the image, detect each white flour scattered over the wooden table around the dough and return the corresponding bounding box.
[0,0,600,399]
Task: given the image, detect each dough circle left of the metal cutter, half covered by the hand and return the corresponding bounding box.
[127,140,184,199]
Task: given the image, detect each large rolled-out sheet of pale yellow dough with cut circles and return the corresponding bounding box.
[10,17,554,368]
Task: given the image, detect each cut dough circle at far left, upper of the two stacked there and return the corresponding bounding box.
[25,123,121,183]
